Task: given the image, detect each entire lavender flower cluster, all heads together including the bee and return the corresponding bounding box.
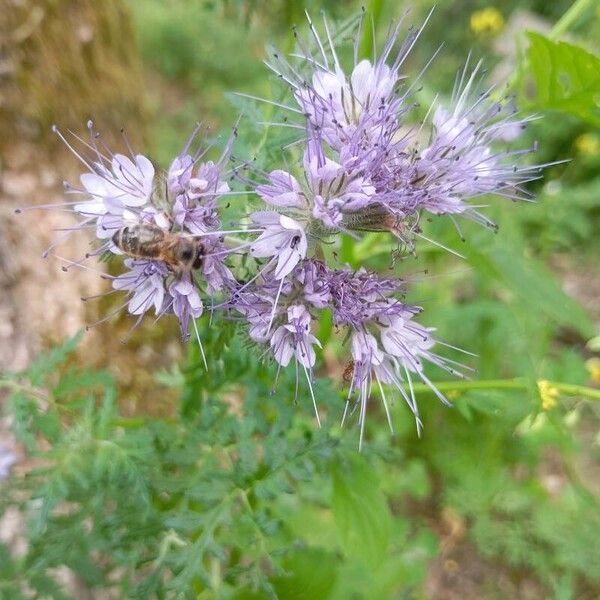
[25,7,541,444]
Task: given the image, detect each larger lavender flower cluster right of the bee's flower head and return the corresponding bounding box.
[226,10,540,441]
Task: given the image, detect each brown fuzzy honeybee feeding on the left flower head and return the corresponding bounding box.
[112,223,204,277]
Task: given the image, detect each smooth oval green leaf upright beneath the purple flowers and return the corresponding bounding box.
[331,456,391,567]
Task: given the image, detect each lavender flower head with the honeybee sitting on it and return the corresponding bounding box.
[45,121,235,339]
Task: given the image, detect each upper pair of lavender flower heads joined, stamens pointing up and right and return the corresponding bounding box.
[257,8,548,250]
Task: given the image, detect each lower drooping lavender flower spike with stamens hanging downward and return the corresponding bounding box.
[230,259,471,447]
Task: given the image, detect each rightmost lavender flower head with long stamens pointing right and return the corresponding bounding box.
[358,65,541,227]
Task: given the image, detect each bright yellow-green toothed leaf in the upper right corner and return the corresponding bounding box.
[527,32,600,125]
